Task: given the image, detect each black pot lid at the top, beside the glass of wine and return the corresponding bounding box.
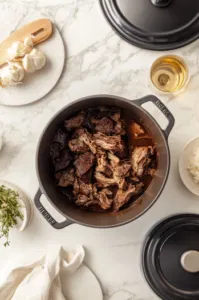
[100,0,199,50]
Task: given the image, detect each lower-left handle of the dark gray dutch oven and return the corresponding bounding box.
[34,189,73,229]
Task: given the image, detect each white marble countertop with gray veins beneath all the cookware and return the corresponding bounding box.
[0,0,199,300]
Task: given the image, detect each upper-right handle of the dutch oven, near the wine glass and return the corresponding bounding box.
[133,95,175,138]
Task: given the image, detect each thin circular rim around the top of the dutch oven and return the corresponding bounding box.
[36,94,170,229]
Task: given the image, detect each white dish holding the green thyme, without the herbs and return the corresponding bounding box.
[0,180,33,231]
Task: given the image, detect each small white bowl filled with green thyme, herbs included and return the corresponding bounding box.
[0,181,32,246]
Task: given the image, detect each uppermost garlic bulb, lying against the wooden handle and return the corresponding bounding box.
[8,37,33,60]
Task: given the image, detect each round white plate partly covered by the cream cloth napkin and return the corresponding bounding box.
[61,264,103,300]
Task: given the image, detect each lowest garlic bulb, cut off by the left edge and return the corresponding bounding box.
[0,62,25,86]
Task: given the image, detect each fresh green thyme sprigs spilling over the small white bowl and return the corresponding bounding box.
[0,185,23,247]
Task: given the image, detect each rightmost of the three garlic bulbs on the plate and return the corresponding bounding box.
[22,49,46,73]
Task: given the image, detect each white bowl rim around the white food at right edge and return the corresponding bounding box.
[179,137,199,196]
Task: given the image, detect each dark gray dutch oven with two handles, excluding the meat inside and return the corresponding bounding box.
[35,95,174,229]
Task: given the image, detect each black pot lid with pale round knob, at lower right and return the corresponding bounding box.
[142,214,199,300]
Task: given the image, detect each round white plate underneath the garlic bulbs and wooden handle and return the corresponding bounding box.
[0,26,65,106]
